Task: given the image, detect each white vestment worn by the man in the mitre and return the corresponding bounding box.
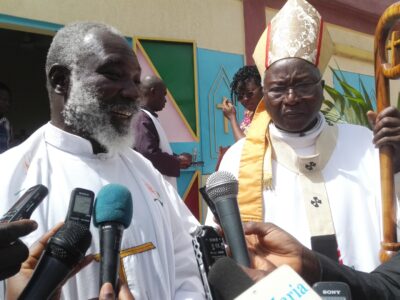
[206,122,397,272]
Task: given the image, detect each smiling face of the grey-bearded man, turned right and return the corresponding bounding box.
[63,31,140,150]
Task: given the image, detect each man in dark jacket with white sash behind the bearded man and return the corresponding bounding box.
[133,76,192,188]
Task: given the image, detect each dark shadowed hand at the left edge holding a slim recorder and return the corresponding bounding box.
[0,220,37,280]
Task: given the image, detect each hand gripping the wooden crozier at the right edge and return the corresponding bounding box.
[367,106,400,173]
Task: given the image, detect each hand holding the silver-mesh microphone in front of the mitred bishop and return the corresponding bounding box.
[243,222,320,284]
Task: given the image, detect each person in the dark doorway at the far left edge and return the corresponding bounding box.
[0,82,12,153]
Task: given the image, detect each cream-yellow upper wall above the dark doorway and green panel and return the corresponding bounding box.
[0,0,244,54]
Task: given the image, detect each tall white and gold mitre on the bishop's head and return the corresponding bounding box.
[253,0,333,76]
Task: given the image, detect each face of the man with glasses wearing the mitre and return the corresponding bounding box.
[264,58,323,132]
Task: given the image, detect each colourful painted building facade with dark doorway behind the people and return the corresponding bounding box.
[0,0,399,220]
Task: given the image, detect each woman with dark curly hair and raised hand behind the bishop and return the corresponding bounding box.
[222,66,263,141]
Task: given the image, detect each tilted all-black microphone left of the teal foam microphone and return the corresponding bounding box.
[18,222,92,300]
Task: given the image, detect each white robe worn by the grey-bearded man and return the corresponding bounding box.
[0,123,204,300]
